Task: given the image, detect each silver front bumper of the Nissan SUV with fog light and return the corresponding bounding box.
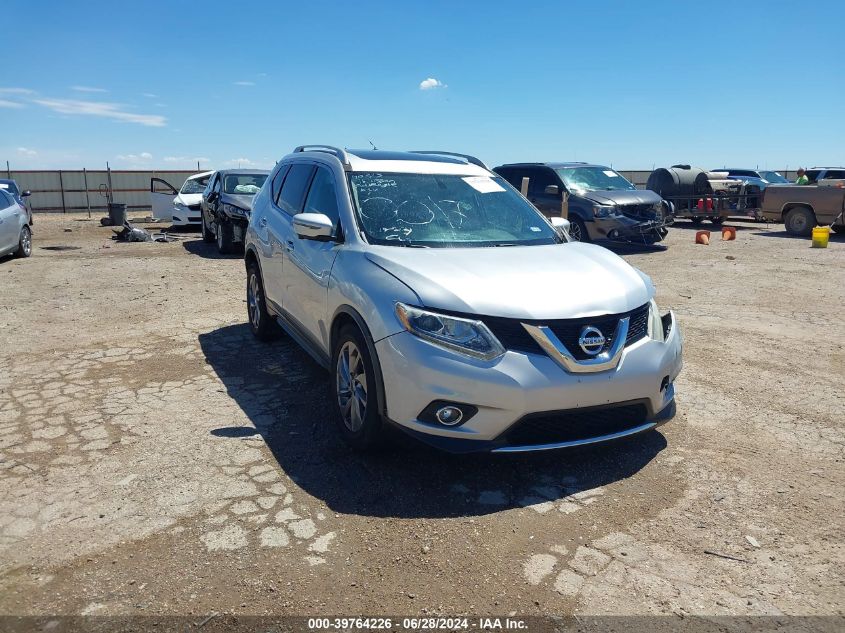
[376,313,683,452]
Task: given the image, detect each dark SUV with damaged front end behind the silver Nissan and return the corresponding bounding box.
[493,163,672,244]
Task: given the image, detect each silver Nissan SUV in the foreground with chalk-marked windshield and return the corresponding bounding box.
[245,146,682,452]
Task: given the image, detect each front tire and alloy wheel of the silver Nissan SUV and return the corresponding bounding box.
[331,325,382,451]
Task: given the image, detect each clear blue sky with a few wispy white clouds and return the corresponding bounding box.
[0,0,845,170]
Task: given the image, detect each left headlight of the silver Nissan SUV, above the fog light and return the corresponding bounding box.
[396,303,505,360]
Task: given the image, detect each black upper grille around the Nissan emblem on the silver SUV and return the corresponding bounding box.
[480,303,649,360]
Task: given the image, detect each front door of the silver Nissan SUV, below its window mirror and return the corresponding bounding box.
[285,166,339,350]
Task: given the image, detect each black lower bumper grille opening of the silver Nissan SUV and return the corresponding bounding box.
[503,403,648,446]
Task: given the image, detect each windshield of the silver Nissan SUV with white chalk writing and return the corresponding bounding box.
[349,172,561,248]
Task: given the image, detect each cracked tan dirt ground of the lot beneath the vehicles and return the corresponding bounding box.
[0,215,845,615]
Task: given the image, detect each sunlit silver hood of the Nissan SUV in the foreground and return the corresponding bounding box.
[367,242,654,319]
